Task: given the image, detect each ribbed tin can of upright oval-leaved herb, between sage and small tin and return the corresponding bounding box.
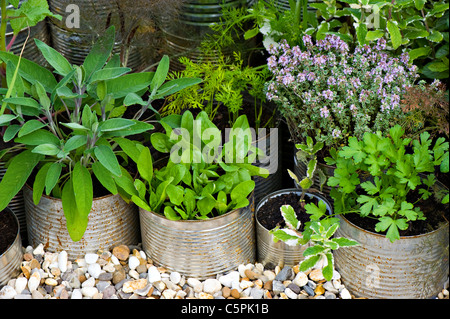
[139,196,256,279]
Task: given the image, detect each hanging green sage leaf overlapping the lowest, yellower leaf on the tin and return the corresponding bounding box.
[72,162,94,219]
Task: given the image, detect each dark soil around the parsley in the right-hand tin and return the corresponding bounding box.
[345,186,450,236]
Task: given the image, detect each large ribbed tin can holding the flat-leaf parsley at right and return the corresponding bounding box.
[333,204,449,299]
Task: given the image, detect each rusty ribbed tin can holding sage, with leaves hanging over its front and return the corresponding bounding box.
[23,186,140,260]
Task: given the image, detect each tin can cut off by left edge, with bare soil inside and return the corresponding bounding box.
[0,208,23,287]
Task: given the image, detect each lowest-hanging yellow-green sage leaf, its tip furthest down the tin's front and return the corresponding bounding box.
[61,178,89,242]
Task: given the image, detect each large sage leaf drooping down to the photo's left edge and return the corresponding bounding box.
[0,150,43,211]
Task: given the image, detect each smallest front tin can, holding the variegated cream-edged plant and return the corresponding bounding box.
[255,188,332,268]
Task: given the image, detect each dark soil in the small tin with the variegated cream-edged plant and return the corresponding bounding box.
[256,193,318,231]
